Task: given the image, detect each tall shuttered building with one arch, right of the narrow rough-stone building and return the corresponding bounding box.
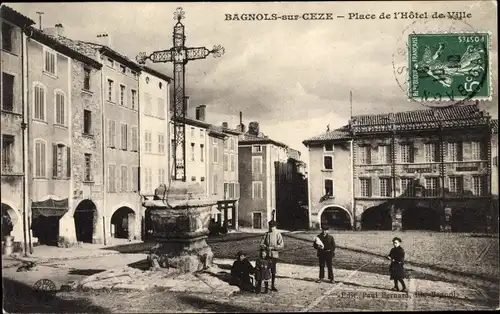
[87,35,142,239]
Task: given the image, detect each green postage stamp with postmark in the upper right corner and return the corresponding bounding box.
[408,33,491,101]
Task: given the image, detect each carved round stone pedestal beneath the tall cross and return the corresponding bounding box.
[143,181,217,273]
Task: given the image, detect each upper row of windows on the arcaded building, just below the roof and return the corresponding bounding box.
[358,141,485,165]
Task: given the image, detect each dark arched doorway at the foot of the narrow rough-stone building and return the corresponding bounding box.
[73,200,97,243]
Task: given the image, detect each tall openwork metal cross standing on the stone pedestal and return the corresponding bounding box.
[136,8,224,181]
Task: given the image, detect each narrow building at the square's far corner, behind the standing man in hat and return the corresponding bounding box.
[238,122,287,229]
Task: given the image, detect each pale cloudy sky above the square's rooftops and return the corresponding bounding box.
[6,1,498,163]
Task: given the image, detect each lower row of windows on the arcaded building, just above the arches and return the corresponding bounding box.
[356,175,486,197]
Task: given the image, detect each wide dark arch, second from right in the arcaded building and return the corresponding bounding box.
[401,207,440,231]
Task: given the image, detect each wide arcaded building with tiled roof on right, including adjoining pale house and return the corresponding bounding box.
[304,105,498,231]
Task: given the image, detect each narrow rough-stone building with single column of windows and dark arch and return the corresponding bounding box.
[39,24,104,246]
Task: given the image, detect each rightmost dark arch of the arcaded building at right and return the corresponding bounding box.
[451,207,487,232]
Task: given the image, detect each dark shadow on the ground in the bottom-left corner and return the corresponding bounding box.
[3,278,111,313]
